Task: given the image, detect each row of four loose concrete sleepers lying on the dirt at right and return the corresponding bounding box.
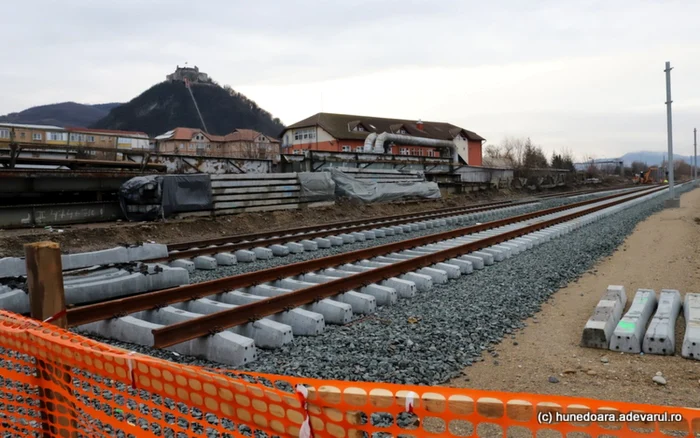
[581,286,700,360]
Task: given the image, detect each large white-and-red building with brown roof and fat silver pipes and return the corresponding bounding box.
[282,113,485,166]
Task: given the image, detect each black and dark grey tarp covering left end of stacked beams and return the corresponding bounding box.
[119,174,213,221]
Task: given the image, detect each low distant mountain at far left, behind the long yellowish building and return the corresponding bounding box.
[0,102,121,126]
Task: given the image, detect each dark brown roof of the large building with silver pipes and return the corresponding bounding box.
[284,113,485,140]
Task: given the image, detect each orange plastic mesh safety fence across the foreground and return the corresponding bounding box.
[0,311,700,438]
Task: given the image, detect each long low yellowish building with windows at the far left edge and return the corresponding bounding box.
[0,123,150,149]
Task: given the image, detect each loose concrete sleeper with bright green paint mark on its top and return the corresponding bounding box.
[610,289,656,353]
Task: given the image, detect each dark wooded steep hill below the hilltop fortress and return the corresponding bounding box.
[92,81,284,137]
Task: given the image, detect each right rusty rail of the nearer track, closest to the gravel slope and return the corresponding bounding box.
[152,184,661,348]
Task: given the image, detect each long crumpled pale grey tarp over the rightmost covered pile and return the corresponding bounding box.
[330,169,441,202]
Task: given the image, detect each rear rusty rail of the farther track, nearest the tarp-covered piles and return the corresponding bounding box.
[168,201,516,251]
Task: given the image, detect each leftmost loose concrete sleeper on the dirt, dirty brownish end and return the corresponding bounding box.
[581,286,627,350]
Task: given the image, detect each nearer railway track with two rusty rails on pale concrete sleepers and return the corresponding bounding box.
[68,183,665,365]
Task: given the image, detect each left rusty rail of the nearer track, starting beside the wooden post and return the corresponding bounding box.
[68,185,661,327]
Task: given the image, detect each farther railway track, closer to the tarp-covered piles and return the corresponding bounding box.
[159,188,639,271]
